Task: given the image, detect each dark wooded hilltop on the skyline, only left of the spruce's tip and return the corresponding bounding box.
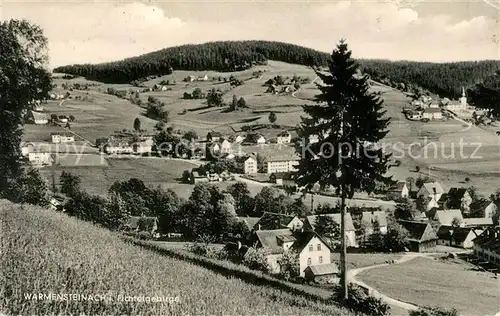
[54,41,328,83]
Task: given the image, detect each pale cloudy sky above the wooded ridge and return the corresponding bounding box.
[0,0,500,67]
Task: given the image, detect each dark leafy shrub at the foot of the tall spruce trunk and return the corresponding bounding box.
[333,284,390,316]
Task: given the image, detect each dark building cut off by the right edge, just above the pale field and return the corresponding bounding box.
[474,226,500,268]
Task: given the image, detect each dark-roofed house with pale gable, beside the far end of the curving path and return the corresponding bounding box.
[398,221,438,252]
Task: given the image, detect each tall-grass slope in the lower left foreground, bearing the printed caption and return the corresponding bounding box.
[0,201,349,315]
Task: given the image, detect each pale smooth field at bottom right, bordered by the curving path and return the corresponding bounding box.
[357,258,500,315]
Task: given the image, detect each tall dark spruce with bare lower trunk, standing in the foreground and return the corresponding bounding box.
[296,40,393,299]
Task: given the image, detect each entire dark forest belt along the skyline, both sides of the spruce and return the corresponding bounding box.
[54,41,500,98]
